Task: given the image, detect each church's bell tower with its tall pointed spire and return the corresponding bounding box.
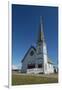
[36,16,48,74]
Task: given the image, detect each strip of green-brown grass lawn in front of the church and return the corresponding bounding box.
[12,74,58,85]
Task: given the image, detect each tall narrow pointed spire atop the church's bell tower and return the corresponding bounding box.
[37,16,44,42]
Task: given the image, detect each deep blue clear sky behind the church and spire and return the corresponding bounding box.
[12,4,58,68]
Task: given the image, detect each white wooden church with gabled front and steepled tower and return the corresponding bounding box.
[21,17,57,74]
